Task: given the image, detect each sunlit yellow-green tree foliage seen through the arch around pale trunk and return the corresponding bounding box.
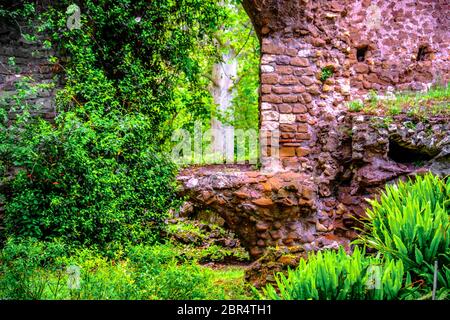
[169,0,260,163]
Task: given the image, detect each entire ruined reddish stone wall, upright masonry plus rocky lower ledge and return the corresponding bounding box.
[180,0,450,262]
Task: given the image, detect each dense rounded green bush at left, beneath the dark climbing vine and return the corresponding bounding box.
[5,112,176,248]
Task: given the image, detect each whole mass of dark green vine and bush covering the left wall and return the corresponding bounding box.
[0,0,223,250]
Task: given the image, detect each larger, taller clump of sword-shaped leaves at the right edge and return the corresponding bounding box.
[360,174,450,286]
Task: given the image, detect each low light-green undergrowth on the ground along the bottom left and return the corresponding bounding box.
[0,240,247,300]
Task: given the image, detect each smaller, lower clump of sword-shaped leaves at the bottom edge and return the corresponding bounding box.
[263,247,405,300]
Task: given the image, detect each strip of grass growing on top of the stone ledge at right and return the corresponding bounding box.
[347,84,450,118]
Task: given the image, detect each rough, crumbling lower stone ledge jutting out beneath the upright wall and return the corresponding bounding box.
[178,114,450,258]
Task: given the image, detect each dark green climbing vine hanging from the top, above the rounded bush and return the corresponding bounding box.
[36,0,223,141]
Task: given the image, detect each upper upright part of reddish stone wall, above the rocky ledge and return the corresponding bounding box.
[244,0,450,172]
